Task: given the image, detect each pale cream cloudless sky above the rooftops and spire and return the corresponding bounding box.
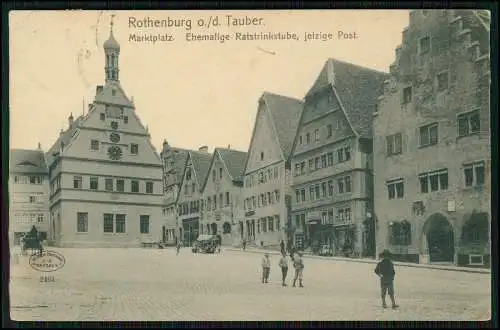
[9,10,409,152]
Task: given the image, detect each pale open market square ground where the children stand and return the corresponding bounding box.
[10,248,491,321]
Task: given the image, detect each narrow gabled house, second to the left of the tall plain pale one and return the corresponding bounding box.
[177,146,212,246]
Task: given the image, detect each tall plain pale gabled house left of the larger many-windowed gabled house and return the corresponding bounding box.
[239,92,303,246]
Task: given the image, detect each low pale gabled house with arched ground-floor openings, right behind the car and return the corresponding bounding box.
[200,148,247,245]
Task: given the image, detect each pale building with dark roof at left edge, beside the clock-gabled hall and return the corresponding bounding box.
[9,145,50,245]
